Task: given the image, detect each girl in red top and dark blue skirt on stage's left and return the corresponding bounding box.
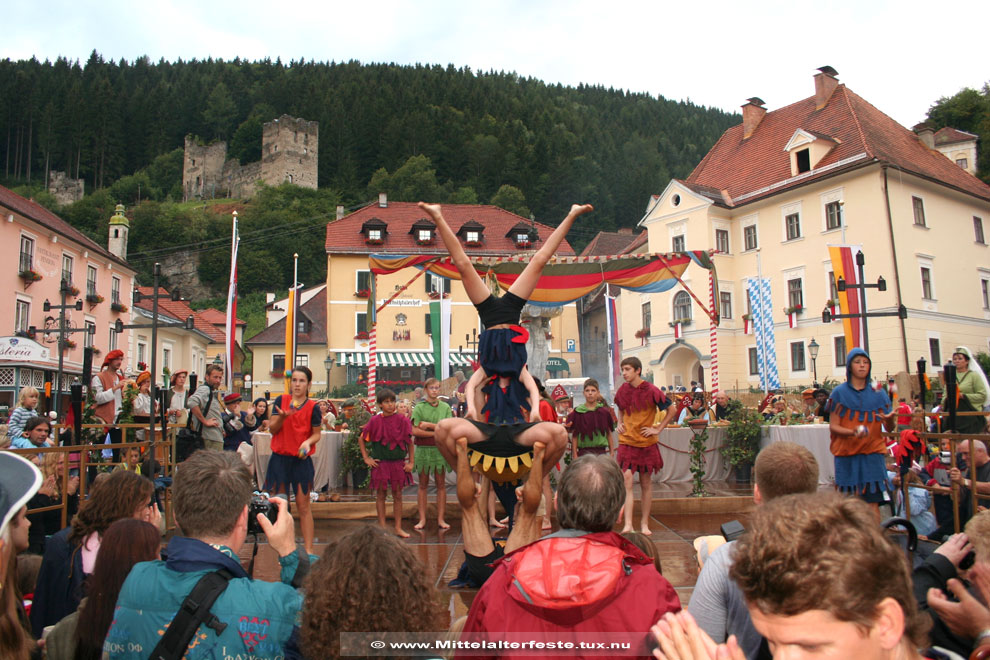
[265,367,322,554]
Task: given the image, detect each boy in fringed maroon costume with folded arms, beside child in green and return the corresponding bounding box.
[358,388,416,538]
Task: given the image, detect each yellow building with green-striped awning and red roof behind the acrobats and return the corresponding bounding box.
[322,195,580,389]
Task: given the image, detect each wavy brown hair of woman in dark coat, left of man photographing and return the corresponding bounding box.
[69,470,155,548]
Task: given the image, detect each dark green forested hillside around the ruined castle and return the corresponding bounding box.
[0,52,739,292]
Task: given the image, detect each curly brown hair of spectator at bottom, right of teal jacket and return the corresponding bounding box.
[301,525,449,658]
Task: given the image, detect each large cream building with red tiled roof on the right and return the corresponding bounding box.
[619,67,990,389]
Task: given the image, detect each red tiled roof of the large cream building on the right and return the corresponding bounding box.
[685,85,990,206]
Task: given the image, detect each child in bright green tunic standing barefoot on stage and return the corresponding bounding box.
[412,378,453,529]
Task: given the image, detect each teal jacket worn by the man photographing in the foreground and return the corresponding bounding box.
[103,537,315,660]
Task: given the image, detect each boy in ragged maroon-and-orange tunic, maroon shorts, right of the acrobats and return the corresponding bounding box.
[615,357,673,536]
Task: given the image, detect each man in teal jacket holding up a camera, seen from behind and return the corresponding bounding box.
[103,450,315,660]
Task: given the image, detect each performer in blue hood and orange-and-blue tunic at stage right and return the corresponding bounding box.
[828,348,897,515]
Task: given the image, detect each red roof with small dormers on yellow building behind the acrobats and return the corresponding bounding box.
[326,202,574,255]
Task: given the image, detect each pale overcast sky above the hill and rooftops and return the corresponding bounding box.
[0,0,990,127]
